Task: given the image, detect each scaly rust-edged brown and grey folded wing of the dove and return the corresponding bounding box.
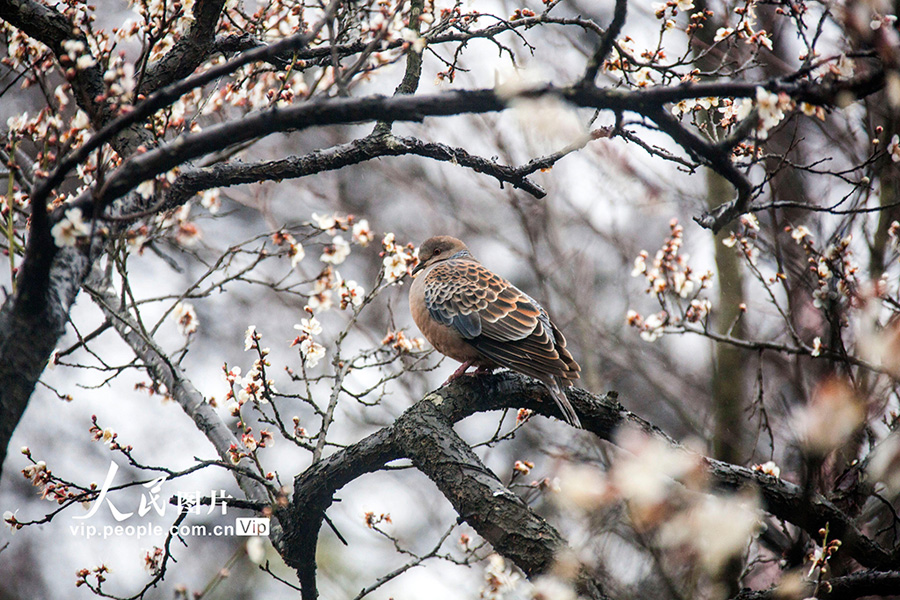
[424,259,578,380]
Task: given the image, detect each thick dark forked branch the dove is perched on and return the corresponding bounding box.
[276,373,896,600]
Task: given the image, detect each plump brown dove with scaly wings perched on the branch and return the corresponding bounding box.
[409,235,581,428]
